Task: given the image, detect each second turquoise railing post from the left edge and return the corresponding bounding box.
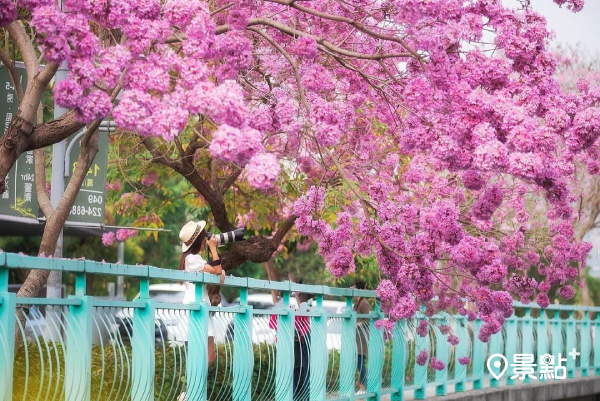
[65,272,93,401]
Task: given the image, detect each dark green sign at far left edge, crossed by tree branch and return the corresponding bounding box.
[0,63,39,218]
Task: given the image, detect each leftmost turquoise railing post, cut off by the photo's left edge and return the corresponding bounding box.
[0,253,17,401]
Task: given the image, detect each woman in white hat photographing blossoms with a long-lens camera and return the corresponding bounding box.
[179,220,225,363]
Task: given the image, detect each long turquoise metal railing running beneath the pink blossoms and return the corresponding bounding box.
[0,253,600,401]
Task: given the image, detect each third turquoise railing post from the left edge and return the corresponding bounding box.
[131,278,156,401]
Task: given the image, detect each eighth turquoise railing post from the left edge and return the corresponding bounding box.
[340,296,357,400]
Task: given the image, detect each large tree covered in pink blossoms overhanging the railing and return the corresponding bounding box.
[0,0,600,340]
